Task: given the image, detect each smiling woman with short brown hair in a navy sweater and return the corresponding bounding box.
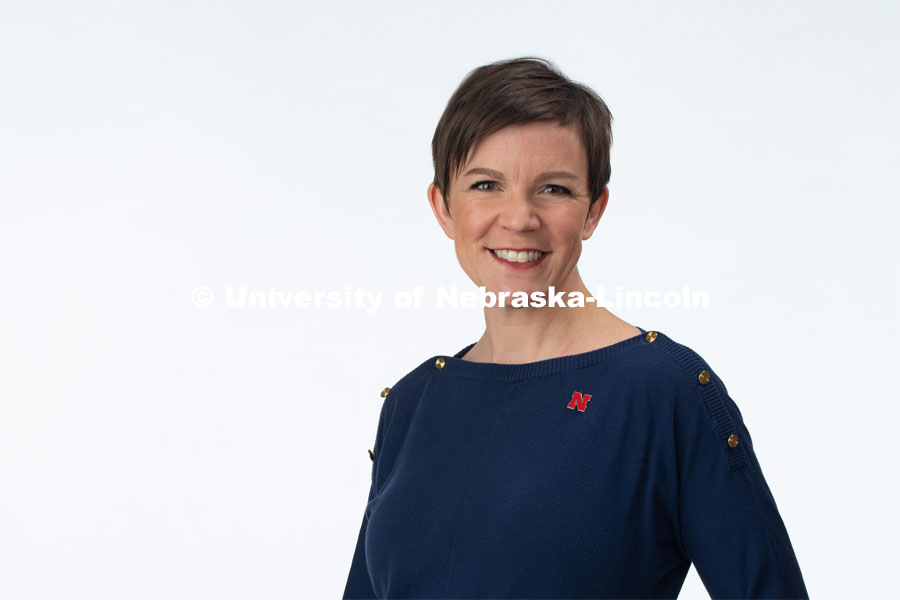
[344,57,808,598]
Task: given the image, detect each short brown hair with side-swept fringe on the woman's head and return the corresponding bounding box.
[431,56,613,210]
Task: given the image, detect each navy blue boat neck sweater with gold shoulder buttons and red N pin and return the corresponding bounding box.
[343,327,809,600]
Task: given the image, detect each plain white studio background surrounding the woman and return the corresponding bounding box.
[0,1,900,600]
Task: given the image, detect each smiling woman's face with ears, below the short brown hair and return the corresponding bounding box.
[428,122,609,293]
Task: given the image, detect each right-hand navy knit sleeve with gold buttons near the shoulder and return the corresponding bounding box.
[674,363,809,598]
